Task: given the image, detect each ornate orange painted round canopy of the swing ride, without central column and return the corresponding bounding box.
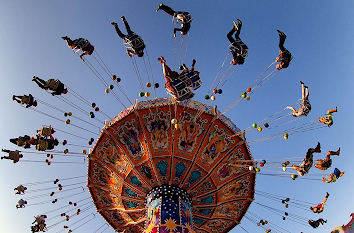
[88,98,255,233]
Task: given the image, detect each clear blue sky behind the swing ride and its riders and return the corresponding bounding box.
[0,0,354,233]
